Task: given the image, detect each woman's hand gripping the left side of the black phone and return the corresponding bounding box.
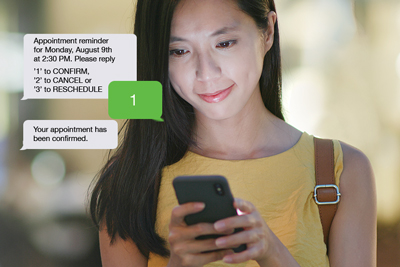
[168,202,233,267]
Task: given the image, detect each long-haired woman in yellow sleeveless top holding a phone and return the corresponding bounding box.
[91,0,376,267]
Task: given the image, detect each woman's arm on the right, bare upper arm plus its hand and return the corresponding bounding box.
[214,141,376,267]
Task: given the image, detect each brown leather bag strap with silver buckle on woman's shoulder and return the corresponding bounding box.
[314,138,340,251]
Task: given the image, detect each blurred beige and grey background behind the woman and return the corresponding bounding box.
[0,0,400,267]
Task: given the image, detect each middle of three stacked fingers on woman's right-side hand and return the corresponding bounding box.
[215,229,264,248]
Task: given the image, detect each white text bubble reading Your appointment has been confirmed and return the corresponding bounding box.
[21,120,118,150]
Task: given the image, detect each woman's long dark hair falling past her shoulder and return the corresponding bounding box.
[90,0,283,257]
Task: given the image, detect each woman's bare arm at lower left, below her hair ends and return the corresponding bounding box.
[99,227,147,267]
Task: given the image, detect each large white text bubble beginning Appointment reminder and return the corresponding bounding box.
[22,34,137,100]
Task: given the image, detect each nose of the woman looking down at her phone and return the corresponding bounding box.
[196,53,221,82]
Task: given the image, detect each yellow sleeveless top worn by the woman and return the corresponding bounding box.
[148,133,343,267]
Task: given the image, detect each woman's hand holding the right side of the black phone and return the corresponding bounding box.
[214,198,299,266]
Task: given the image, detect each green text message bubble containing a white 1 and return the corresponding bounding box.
[108,81,164,121]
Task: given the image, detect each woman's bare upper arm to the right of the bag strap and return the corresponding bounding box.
[329,143,376,267]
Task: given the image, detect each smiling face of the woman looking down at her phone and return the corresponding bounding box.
[169,0,270,120]
